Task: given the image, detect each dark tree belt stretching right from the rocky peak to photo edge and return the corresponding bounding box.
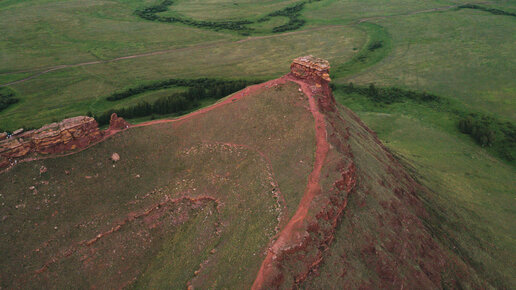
[330,83,516,162]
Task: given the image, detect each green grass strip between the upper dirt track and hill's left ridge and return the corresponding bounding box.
[0,27,365,130]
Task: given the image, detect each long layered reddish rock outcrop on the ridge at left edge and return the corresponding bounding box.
[0,116,102,168]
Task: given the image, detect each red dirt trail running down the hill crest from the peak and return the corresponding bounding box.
[252,77,329,289]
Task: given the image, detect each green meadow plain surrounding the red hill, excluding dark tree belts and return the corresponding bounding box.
[0,0,516,288]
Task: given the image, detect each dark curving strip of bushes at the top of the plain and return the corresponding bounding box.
[134,0,321,35]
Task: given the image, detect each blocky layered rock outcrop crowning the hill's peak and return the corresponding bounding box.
[290,55,331,86]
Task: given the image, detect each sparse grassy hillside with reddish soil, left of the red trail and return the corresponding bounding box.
[0,84,315,288]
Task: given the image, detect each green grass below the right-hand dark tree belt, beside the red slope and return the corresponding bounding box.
[336,91,516,288]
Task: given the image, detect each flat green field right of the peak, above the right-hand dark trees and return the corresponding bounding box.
[338,9,516,121]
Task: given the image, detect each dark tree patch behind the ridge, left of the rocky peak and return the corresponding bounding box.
[94,78,261,126]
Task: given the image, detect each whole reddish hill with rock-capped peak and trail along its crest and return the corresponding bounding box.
[0,57,492,289]
